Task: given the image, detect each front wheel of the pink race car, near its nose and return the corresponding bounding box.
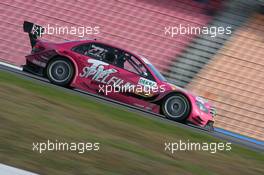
[161,93,191,122]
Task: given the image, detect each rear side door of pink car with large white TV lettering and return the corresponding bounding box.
[73,43,115,93]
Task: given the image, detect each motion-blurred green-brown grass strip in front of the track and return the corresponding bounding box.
[0,72,264,175]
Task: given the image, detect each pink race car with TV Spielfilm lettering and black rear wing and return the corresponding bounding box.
[23,21,216,131]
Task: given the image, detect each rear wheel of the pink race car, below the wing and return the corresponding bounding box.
[46,58,74,87]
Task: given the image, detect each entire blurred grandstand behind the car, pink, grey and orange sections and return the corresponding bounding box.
[0,0,264,140]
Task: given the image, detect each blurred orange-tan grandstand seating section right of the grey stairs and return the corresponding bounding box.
[188,14,264,140]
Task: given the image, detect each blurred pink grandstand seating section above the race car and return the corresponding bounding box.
[0,0,219,70]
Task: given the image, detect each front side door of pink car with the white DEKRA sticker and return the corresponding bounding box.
[105,51,159,108]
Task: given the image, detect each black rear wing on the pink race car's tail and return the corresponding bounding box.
[23,21,44,47]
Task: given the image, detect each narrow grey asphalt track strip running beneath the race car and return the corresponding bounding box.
[0,64,264,152]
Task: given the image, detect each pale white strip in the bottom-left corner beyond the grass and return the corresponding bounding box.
[0,163,38,175]
